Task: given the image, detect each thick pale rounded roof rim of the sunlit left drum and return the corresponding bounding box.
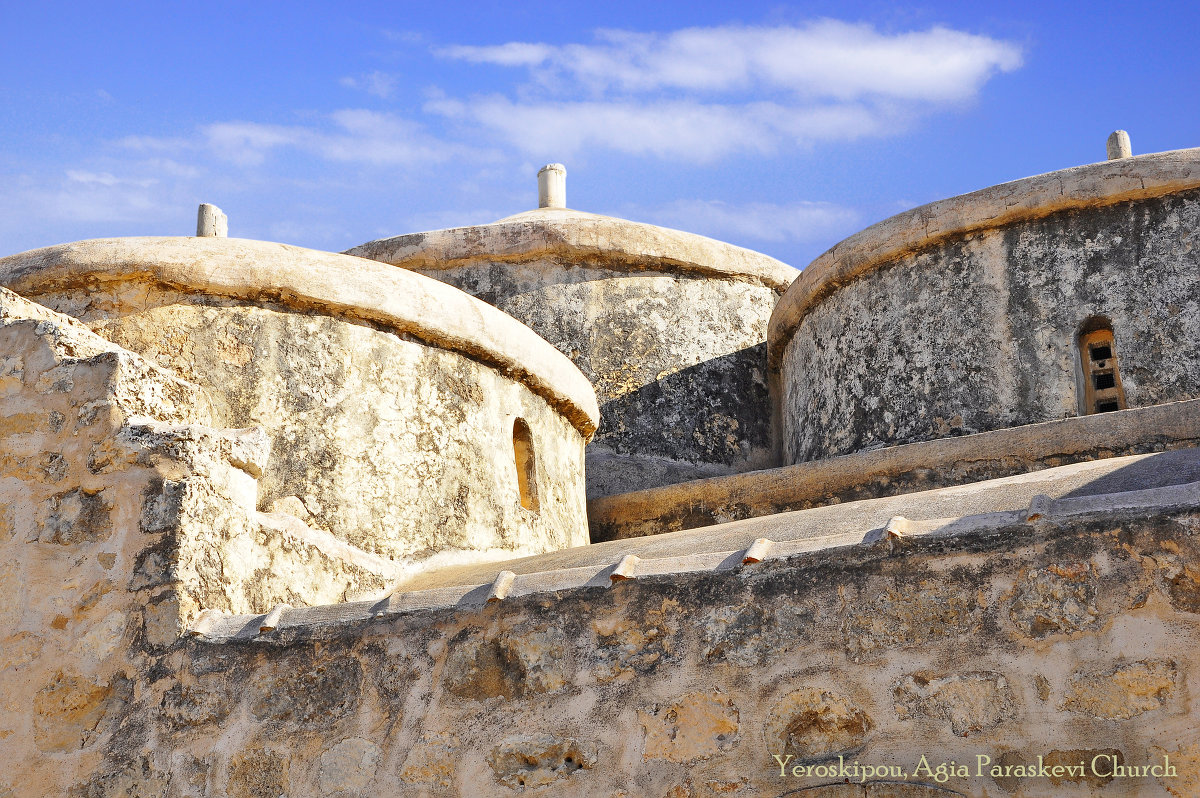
[0,236,600,439]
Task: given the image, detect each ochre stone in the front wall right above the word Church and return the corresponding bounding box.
[1062,660,1178,720]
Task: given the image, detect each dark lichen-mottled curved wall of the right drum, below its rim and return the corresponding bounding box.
[781,190,1200,463]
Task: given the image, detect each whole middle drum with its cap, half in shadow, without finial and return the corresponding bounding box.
[348,209,797,497]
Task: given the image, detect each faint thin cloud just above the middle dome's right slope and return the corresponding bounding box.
[628,199,859,242]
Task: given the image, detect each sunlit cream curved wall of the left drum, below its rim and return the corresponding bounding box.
[24,283,587,562]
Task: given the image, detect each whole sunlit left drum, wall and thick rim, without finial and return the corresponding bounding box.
[0,238,598,560]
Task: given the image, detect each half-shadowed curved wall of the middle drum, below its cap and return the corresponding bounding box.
[416,258,778,497]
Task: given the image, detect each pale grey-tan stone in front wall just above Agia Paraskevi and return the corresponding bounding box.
[895,671,1018,737]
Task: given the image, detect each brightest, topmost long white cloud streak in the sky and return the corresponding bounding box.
[437,19,1021,102]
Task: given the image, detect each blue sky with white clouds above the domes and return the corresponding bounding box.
[0,0,1200,268]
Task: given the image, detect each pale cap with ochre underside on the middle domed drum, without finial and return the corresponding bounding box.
[346,209,799,294]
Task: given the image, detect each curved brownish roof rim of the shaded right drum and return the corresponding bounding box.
[767,148,1200,371]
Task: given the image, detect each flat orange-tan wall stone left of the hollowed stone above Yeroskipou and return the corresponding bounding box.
[637,691,740,762]
